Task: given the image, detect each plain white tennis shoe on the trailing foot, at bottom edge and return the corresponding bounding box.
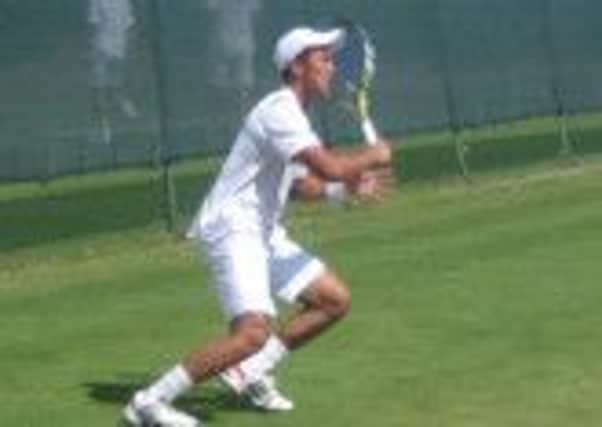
[123,391,202,427]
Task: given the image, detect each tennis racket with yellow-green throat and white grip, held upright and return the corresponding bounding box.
[334,20,379,145]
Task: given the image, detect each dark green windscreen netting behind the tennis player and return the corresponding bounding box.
[0,0,602,181]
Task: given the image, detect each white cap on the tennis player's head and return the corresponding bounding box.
[274,27,344,72]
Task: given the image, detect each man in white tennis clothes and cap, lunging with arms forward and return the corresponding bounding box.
[124,28,391,427]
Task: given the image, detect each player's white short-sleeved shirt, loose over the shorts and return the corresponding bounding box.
[189,87,321,242]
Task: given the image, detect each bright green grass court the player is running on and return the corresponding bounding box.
[0,146,602,427]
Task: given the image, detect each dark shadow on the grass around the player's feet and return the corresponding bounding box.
[83,381,256,421]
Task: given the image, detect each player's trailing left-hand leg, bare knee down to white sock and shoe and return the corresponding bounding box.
[124,313,270,426]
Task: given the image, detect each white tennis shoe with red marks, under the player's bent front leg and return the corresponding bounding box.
[220,366,295,412]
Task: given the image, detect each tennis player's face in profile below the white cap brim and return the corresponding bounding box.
[293,47,335,97]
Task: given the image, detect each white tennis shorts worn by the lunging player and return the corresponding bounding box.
[202,232,325,319]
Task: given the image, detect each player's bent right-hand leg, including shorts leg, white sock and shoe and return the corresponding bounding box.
[221,228,349,411]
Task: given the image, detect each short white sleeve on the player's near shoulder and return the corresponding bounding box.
[262,97,321,161]
